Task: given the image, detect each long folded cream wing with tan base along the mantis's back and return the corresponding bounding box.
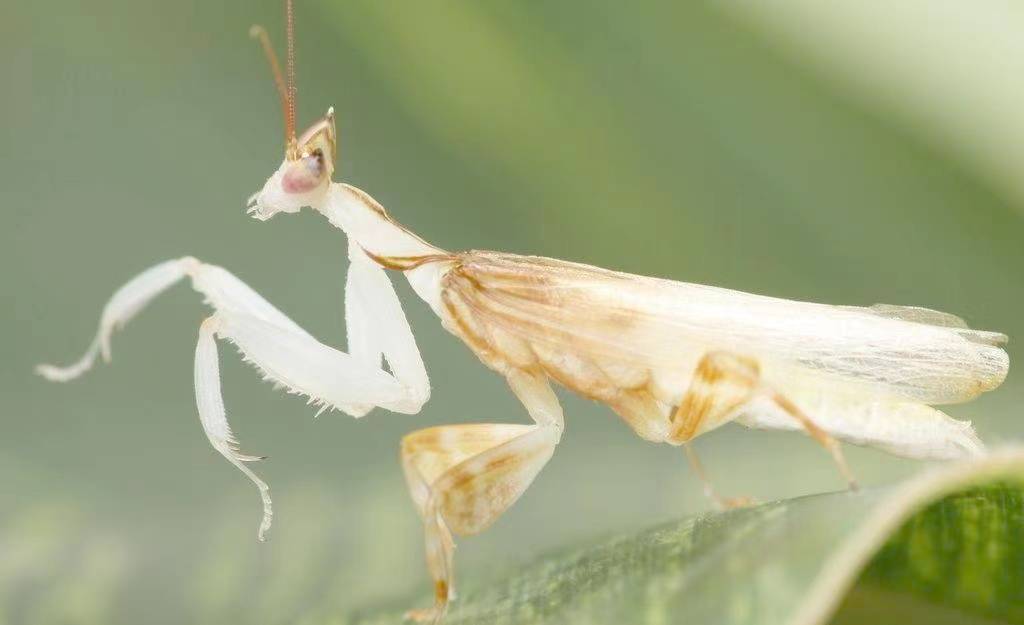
[445,252,1009,405]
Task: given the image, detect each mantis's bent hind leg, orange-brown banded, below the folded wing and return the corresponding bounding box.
[669,351,857,489]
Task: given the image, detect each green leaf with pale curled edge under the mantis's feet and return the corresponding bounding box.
[353,450,1024,625]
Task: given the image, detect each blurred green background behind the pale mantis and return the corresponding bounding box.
[0,0,1024,625]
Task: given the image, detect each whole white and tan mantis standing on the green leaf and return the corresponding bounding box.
[38,0,1009,623]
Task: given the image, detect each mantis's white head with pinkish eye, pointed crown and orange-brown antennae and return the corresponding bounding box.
[247,0,337,220]
